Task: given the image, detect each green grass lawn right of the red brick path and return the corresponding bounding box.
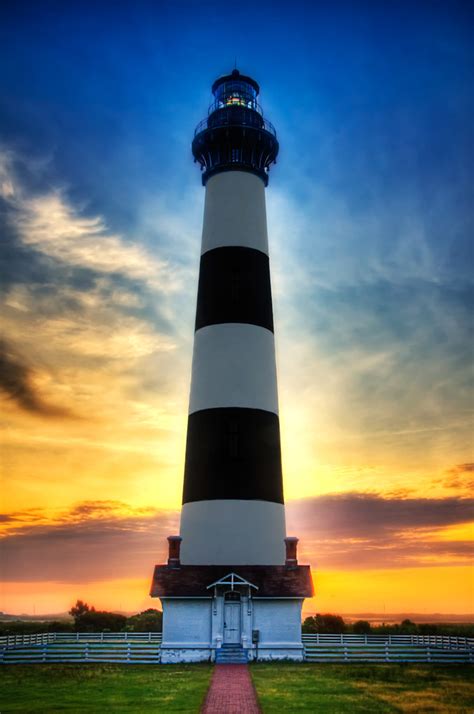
[250,663,474,714]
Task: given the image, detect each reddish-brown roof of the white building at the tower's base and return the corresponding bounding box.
[150,565,314,598]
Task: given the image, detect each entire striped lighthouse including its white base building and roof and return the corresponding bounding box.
[151,69,313,662]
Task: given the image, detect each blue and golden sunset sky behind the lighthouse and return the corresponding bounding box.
[0,0,474,614]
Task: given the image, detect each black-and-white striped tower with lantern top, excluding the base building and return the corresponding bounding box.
[180,70,285,565]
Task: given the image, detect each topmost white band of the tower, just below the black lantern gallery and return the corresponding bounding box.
[201,171,268,255]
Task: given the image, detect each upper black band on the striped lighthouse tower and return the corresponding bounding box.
[195,246,273,332]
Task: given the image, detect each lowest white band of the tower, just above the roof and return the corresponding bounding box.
[180,498,286,565]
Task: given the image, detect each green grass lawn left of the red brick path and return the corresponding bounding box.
[0,664,212,714]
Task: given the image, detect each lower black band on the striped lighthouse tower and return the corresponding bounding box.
[183,407,284,503]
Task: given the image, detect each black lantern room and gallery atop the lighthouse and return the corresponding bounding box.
[192,69,279,186]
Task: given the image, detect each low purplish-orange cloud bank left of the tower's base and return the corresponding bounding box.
[0,501,179,583]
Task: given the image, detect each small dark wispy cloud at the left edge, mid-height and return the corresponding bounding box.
[0,340,74,418]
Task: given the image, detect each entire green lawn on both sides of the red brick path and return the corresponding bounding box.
[0,663,474,714]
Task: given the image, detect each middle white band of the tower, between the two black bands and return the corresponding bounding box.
[189,323,278,414]
